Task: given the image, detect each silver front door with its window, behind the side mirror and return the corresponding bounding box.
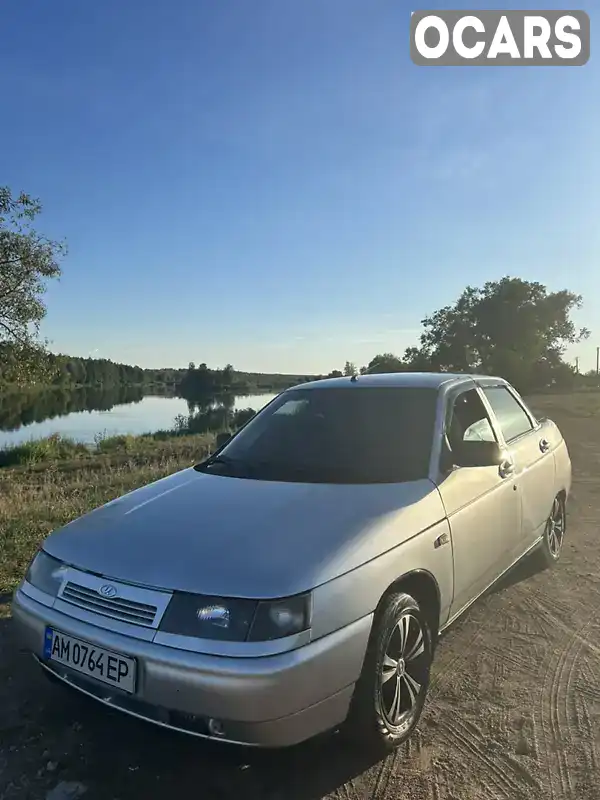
[438,388,521,616]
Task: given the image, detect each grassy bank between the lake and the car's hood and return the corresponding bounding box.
[0,432,214,595]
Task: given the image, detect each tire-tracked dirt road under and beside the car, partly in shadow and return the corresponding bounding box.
[0,398,600,800]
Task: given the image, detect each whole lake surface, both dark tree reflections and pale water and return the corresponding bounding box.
[0,386,273,447]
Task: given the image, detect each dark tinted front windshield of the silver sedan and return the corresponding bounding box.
[201,385,437,483]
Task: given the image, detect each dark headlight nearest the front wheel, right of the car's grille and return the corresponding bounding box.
[159,592,310,642]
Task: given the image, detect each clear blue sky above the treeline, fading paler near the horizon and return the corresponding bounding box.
[0,0,600,372]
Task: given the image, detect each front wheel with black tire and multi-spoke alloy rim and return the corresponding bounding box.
[343,593,433,755]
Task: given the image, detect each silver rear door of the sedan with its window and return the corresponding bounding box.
[481,382,560,560]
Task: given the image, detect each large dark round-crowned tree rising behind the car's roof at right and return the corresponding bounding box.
[404,277,589,390]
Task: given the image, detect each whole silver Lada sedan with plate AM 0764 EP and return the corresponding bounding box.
[13,373,571,751]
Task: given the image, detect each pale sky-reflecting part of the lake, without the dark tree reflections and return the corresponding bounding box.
[0,394,275,448]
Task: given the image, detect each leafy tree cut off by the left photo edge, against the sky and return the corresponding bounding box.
[0,187,66,382]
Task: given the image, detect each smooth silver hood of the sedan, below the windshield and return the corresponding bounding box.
[44,468,444,599]
